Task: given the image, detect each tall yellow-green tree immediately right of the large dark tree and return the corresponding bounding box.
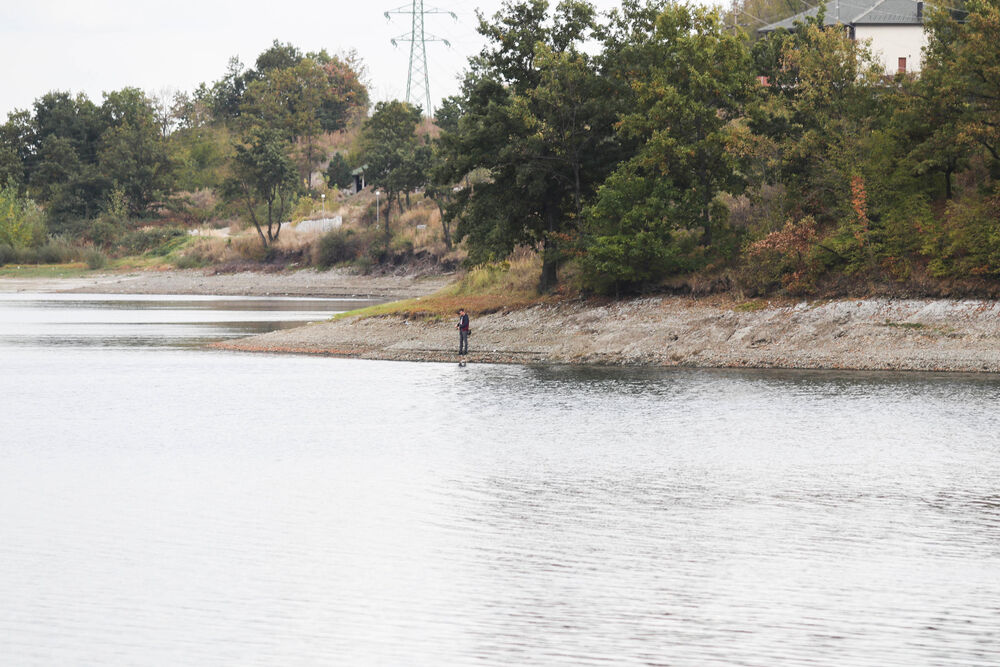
[584,5,755,290]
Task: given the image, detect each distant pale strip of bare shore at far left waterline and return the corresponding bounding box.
[0,269,452,300]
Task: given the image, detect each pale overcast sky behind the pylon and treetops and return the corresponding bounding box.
[0,0,644,121]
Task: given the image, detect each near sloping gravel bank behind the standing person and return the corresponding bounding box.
[216,297,1000,373]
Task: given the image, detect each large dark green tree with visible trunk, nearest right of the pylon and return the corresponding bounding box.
[442,0,616,291]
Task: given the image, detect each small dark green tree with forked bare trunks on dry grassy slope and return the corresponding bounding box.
[223,128,299,247]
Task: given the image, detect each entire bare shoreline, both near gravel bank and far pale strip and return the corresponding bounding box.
[7,269,1000,373]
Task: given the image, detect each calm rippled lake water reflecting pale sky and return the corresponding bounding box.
[0,295,1000,666]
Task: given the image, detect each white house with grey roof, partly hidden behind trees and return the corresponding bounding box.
[758,0,927,74]
